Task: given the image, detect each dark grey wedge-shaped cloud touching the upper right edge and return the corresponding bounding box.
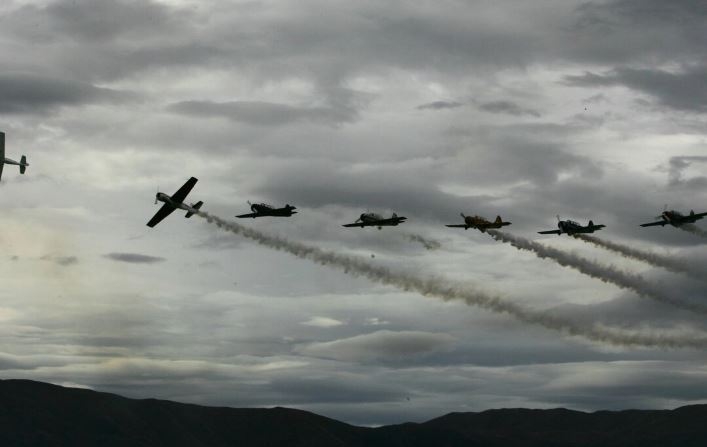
[565,66,707,113]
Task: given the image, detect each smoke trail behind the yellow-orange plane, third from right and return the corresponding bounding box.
[488,230,707,314]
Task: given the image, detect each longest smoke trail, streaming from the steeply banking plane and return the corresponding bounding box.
[197,211,707,348]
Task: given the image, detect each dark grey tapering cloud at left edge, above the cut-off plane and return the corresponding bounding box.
[0,74,130,114]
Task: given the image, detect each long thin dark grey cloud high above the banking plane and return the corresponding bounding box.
[168,101,357,126]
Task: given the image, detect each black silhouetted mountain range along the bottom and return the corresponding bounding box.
[0,380,707,447]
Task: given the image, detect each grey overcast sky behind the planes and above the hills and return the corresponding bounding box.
[0,0,707,424]
